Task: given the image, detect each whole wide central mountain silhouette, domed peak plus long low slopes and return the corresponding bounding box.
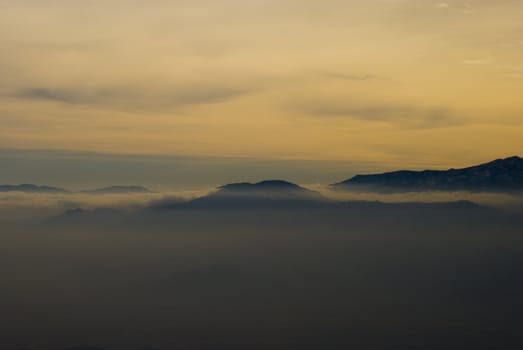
[45,180,495,230]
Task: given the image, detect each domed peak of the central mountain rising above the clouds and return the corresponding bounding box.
[155,180,330,209]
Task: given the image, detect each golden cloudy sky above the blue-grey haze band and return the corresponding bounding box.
[0,0,523,166]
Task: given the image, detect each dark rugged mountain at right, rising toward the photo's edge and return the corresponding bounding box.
[331,156,523,193]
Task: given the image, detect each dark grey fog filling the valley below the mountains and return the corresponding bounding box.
[0,193,523,350]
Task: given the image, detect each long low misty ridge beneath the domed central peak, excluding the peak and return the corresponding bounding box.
[49,195,492,232]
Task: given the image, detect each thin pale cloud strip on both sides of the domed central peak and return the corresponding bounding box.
[4,184,523,222]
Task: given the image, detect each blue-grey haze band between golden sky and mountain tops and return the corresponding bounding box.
[0,148,515,191]
